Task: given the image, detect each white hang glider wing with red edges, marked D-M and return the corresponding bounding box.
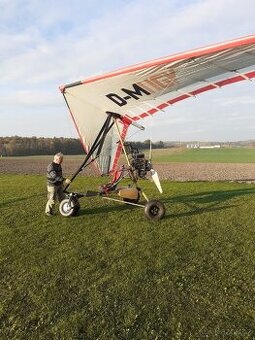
[60,35,255,173]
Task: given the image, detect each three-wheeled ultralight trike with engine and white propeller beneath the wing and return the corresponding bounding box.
[59,112,165,220]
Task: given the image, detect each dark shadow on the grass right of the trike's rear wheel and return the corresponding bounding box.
[163,188,255,218]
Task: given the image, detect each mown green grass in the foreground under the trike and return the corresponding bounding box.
[0,175,255,340]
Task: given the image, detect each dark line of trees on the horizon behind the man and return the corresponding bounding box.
[0,136,164,157]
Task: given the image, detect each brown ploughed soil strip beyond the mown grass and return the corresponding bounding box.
[0,158,255,182]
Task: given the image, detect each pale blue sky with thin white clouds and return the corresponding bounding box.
[0,0,255,141]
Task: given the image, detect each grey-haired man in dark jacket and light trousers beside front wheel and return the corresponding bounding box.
[45,152,71,216]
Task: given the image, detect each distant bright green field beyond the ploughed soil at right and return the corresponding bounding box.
[153,148,255,163]
